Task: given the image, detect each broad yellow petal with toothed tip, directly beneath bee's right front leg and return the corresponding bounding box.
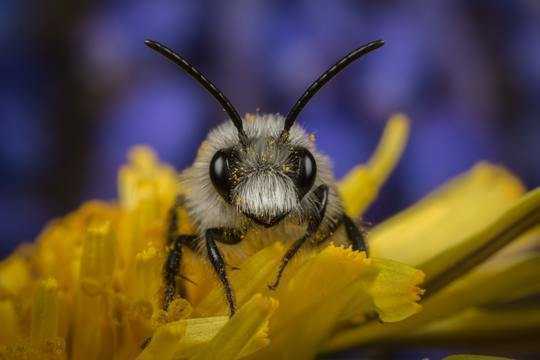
[255,245,422,359]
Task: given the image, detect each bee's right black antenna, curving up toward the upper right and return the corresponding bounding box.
[280,40,384,139]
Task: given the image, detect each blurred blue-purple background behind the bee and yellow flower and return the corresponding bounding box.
[0,0,540,255]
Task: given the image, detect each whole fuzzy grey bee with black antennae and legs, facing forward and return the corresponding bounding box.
[145,40,384,316]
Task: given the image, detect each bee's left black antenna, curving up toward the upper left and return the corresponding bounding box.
[144,40,247,145]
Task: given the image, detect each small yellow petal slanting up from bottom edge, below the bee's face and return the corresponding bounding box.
[193,294,277,360]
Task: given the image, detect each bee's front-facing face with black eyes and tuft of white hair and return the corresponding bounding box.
[209,137,317,226]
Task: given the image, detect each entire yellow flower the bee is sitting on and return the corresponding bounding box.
[0,115,540,359]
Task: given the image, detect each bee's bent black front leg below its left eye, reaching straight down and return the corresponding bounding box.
[205,228,242,316]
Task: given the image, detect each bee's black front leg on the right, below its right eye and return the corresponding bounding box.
[268,185,328,290]
